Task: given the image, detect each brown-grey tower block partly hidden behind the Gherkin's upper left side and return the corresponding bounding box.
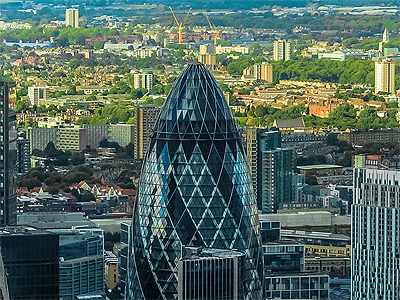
[133,105,161,159]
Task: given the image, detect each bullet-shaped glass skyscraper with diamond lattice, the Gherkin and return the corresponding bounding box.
[126,63,263,299]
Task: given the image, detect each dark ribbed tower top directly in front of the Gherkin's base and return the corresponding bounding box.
[178,246,246,300]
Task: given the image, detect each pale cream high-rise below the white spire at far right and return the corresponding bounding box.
[375,61,396,94]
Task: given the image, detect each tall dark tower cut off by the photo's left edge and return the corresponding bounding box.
[0,82,17,226]
